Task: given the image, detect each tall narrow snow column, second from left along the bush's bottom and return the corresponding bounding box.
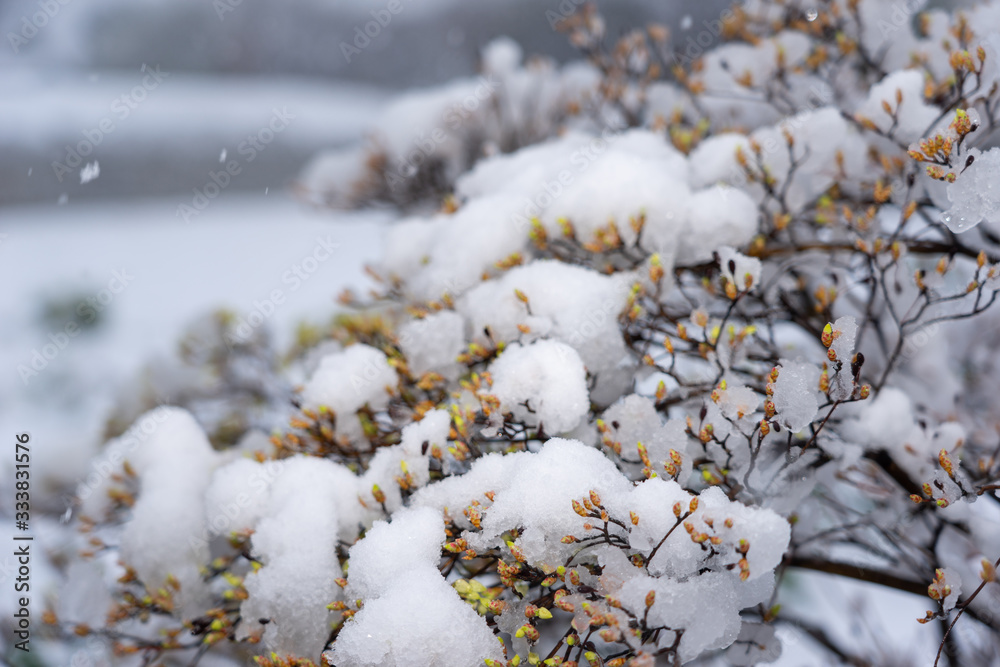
[240,456,348,658]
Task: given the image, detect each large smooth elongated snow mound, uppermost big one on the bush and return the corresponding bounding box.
[458,129,757,262]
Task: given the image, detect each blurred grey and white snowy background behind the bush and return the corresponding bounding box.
[0,0,944,665]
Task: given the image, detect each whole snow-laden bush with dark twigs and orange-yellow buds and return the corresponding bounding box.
[39,0,1000,667]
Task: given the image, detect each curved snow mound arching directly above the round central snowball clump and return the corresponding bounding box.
[456,260,632,403]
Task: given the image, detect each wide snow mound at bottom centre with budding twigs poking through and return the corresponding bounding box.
[402,440,791,664]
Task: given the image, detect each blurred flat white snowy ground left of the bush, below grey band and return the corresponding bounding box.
[0,189,386,496]
